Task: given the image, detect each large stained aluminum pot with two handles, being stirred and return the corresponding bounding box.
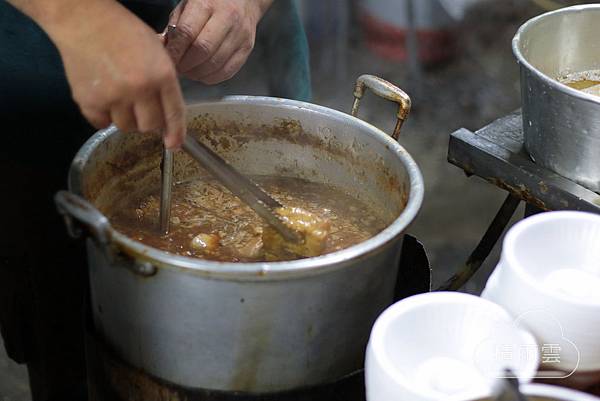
[57,76,424,392]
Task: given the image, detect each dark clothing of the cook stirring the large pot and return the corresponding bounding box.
[0,0,310,401]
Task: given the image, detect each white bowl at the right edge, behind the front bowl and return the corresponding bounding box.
[482,212,600,375]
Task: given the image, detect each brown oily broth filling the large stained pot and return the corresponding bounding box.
[109,176,389,262]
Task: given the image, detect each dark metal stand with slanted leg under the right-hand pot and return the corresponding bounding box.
[438,111,600,290]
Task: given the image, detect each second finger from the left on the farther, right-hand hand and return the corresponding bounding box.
[177,9,232,73]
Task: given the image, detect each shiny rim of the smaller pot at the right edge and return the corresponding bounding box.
[512,4,600,104]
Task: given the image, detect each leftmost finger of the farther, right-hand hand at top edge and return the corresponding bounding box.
[167,1,213,65]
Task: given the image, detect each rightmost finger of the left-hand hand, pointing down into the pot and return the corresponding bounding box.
[161,76,186,149]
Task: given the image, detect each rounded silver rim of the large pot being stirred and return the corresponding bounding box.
[69,96,425,279]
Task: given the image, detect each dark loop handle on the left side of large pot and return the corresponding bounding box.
[54,191,110,245]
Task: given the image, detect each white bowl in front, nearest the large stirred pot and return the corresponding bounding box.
[365,292,539,401]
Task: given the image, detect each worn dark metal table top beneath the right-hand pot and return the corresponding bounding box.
[448,111,600,213]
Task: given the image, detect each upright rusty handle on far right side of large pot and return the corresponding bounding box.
[351,74,412,140]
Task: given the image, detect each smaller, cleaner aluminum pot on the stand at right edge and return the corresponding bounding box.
[513,4,600,192]
